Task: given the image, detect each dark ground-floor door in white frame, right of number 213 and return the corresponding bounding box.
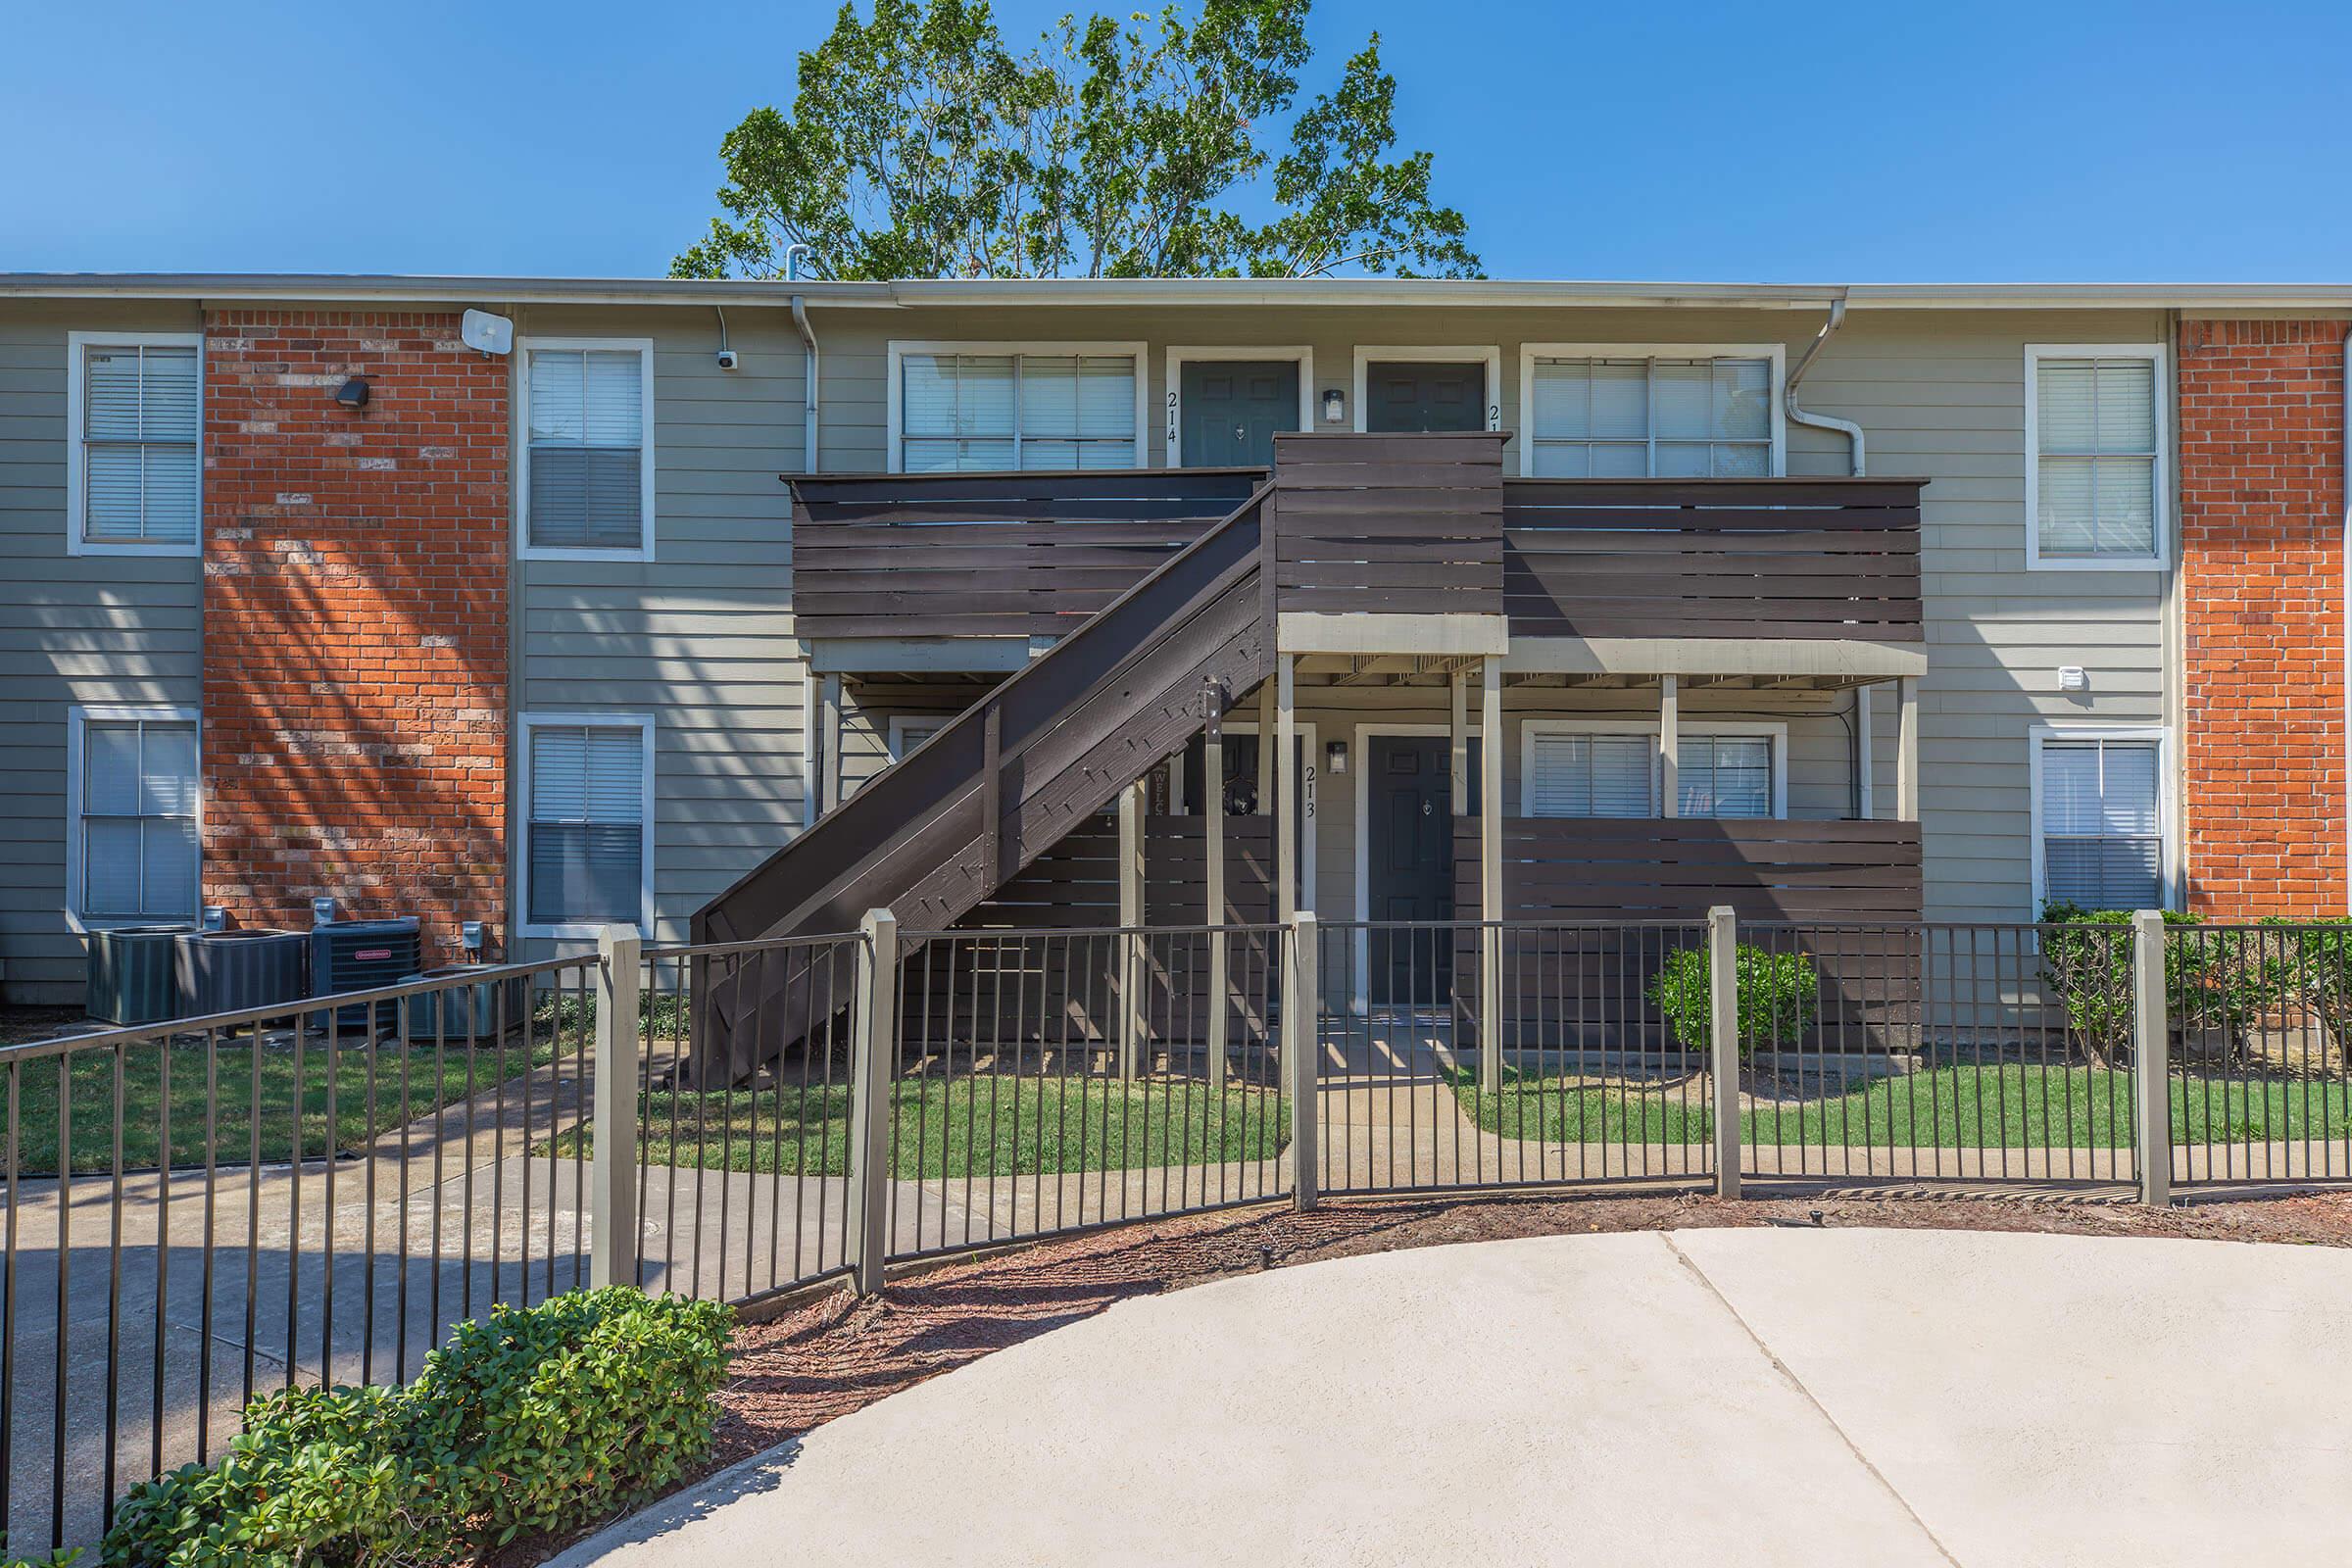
[1364,736,1477,1004]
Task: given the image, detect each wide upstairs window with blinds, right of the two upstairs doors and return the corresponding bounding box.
[1529,358,1774,479]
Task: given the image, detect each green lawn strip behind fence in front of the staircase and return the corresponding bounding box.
[558,1077,1292,1180]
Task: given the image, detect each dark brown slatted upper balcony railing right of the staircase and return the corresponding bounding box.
[1503,479,1924,642]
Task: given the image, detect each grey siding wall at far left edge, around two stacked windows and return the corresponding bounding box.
[0,301,202,1002]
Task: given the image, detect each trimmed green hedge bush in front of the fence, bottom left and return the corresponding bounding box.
[101,1289,734,1568]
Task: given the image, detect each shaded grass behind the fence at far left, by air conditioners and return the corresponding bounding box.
[0,1030,574,1175]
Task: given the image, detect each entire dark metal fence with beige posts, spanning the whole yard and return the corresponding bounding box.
[18,909,2352,1549]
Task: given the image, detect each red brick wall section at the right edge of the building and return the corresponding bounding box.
[2180,319,2345,917]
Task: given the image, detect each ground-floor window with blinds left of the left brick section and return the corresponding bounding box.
[75,717,200,921]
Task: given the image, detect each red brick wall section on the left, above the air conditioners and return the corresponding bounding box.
[205,311,508,961]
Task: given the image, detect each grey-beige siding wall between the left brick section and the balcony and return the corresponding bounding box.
[515,308,807,950]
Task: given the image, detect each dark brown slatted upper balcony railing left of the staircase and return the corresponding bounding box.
[793,467,1263,639]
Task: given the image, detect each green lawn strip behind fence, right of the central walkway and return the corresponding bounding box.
[1453,1062,2352,1150]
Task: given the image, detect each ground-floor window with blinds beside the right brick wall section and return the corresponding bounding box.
[2041,741,2164,909]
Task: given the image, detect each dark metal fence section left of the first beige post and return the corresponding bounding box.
[0,956,598,1551]
